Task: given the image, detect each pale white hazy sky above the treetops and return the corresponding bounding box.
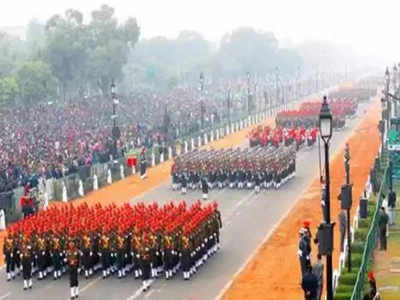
[0,0,400,60]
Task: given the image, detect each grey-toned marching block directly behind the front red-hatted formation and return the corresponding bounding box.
[171,146,296,199]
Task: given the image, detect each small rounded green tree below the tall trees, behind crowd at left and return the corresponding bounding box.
[17,61,56,105]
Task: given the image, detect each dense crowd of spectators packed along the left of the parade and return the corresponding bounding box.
[0,81,266,192]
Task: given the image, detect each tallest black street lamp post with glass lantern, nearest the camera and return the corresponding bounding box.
[319,96,333,300]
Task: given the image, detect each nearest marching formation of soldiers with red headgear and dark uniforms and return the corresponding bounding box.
[3,201,222,299]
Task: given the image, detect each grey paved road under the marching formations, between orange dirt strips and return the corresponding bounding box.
[0,101,374,300]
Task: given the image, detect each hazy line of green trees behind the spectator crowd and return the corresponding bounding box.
[0,5,356,105]
